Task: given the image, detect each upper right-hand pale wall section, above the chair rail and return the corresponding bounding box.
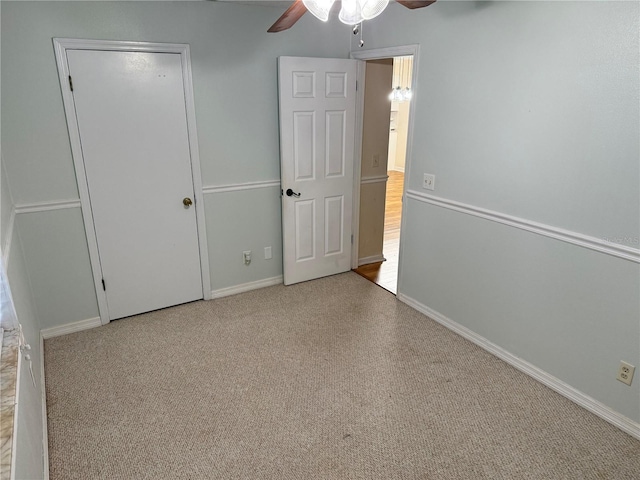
[352,1,640,240]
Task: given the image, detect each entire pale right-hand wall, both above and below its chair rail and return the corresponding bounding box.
[352,2,640,422]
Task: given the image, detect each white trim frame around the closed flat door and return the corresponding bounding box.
[53,38,211,325]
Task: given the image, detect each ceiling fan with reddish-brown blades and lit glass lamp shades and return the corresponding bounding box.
[267,0,436,33]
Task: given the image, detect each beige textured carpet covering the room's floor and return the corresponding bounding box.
[45,273,640,480]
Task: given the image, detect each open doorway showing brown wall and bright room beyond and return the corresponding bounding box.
[355,55,413,294]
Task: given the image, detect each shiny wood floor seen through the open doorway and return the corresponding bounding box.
[355,170,404,294]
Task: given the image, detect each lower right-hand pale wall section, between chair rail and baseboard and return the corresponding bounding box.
[399,200,640,421]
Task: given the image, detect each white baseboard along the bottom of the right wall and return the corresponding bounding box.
[398,294,640,440]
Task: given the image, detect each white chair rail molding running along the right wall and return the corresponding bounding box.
[406,190,640,263]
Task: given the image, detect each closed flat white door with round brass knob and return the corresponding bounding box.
[67,50,203,320]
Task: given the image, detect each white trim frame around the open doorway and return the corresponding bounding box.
[351,44,420,294]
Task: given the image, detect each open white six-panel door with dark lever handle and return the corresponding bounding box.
[278,57,357,285]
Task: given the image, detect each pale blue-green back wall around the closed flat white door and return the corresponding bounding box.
[0,1,351,322]
